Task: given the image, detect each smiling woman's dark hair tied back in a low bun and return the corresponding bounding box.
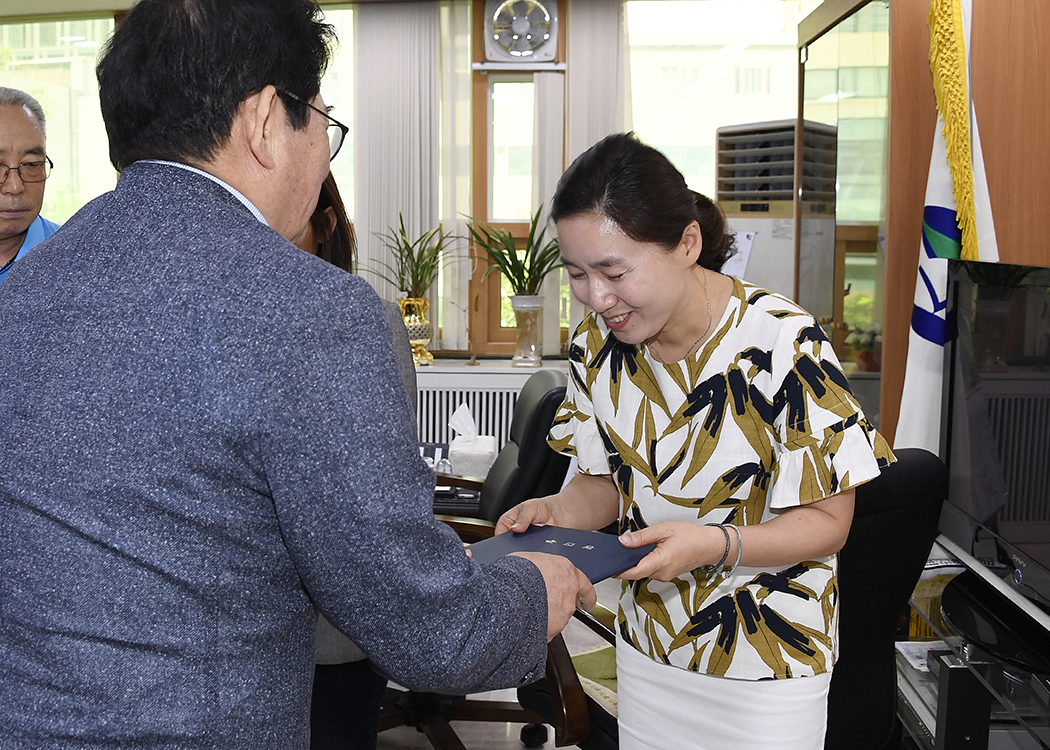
[550,132,736,271]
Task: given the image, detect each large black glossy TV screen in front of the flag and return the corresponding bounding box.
[940,261,1050,605]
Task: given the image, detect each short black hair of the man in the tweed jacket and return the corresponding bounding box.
[96,0,335,169]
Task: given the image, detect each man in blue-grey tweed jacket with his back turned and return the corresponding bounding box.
[0,0,593,750]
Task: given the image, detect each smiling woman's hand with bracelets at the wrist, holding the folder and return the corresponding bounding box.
[616,521,736,581]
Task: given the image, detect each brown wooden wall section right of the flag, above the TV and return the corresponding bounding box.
[970,0,1050,266]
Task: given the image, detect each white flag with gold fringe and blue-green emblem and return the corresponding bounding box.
[894,0,999,453]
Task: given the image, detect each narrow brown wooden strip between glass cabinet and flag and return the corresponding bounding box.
[879,0,937,441]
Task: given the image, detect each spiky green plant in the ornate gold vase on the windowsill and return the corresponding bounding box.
[376,211,455,367]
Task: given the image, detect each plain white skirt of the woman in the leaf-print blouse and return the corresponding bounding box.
[616,634,832,750]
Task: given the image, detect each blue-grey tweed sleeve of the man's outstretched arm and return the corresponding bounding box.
[261,274,547,693]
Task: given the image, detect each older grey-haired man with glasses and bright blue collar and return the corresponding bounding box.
[0,86,59,284]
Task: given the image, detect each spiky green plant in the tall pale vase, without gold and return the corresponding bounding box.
[467,206,562,367]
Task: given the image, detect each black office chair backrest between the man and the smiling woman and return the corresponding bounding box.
[479,369,569,521]
